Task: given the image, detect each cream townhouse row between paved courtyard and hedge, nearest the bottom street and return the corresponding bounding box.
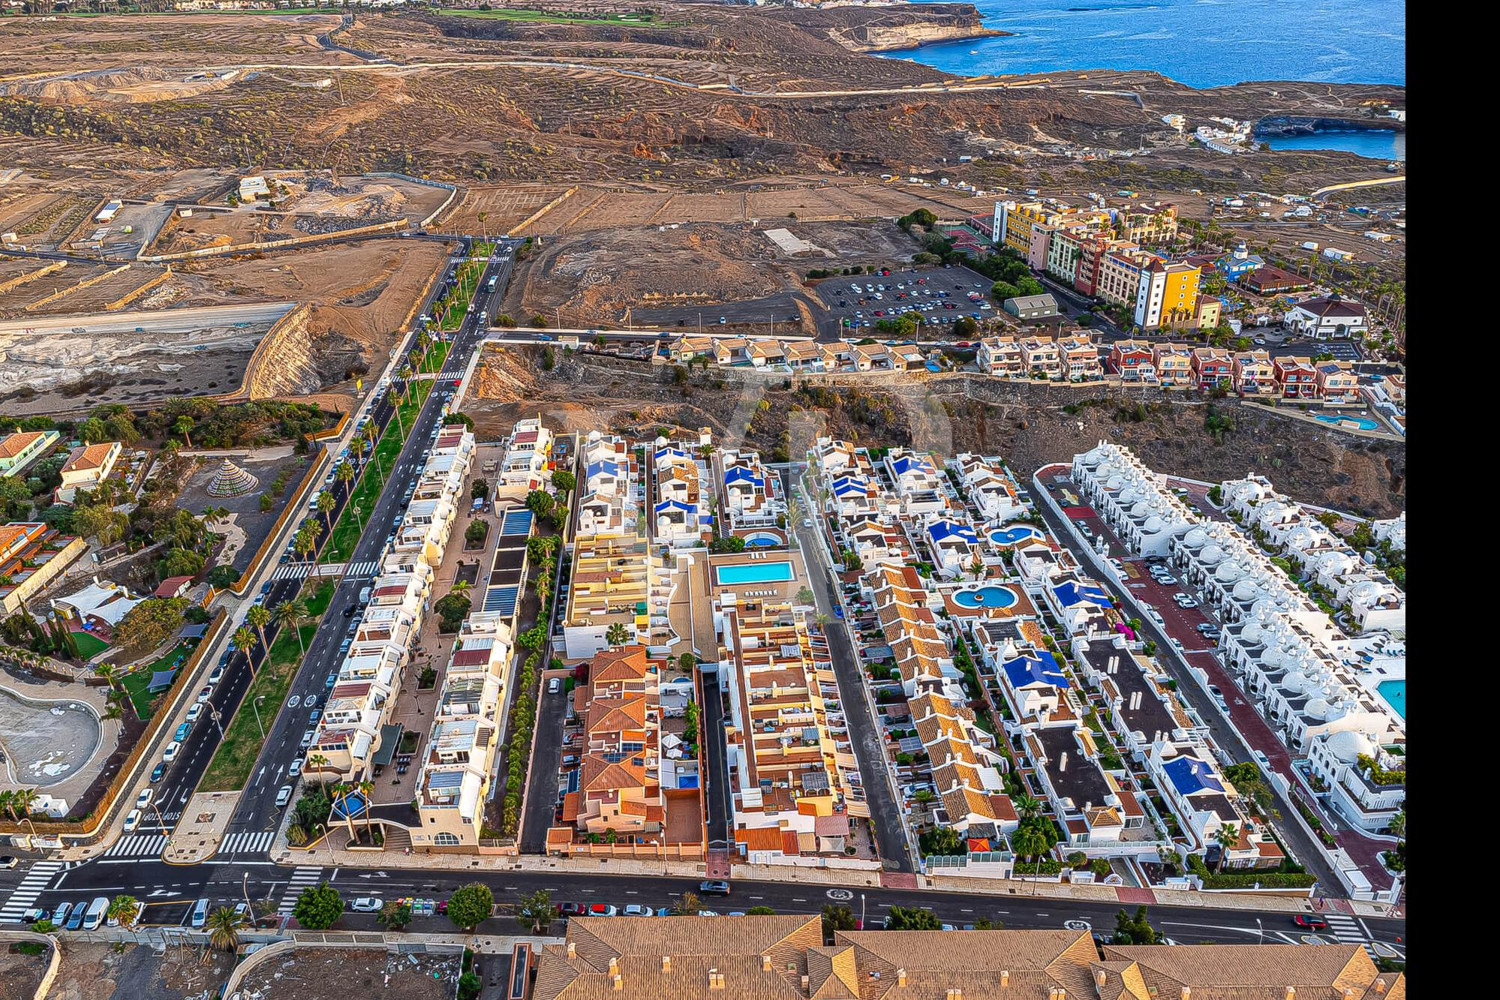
[410,612,515,850]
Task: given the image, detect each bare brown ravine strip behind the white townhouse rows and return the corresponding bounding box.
[464,348,1406,517]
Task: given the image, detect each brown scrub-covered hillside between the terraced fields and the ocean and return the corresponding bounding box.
[0,11,1404,189]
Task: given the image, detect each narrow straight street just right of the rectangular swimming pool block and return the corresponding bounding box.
[783,471,917,873]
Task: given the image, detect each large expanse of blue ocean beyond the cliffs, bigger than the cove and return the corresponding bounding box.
[887,0,1406,87]
